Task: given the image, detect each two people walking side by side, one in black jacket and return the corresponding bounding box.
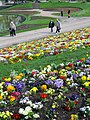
[49,19,61,33]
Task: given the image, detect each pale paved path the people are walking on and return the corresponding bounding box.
[0,9,90,48]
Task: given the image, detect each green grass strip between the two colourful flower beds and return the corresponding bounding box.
[0,47,90,79]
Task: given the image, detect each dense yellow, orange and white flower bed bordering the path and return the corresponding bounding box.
[0,28,90,63]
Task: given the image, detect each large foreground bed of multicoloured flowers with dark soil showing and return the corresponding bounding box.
[0,58,90,120]
